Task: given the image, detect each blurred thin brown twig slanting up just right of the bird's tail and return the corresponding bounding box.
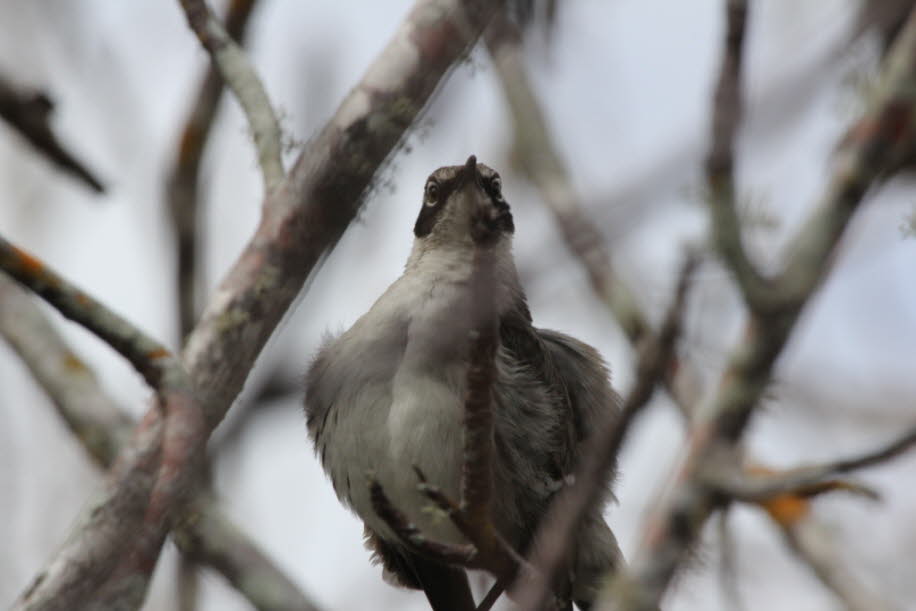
[518,255,697,609]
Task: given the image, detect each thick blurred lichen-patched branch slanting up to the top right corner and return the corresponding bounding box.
[601,11,916,609]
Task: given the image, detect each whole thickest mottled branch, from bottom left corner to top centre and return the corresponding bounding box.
[10,0,502,608]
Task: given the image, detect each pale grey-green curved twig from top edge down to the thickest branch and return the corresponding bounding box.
[180,0,284,193]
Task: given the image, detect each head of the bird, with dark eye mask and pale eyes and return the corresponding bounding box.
[413,155,515,245]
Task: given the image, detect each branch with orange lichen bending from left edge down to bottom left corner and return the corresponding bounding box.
[0,238,206,608]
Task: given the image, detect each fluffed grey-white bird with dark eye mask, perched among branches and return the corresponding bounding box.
[305,155,622,611]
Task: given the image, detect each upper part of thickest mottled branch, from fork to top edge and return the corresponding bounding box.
[184,0,500,427]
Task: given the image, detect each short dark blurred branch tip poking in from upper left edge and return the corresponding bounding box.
[0,77,105,193]
